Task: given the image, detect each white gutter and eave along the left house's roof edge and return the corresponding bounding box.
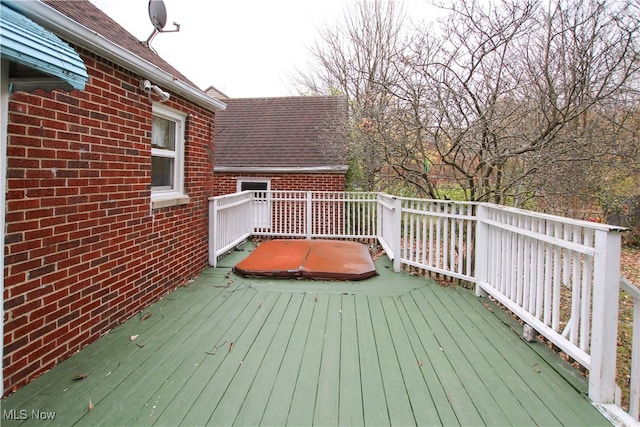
[6,0,226,111]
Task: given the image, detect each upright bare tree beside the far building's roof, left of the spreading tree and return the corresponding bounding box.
[297,1,406,190]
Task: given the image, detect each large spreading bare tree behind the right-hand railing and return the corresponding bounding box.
[404,1,638,204]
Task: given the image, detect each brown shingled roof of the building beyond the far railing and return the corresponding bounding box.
[214,96,347,173]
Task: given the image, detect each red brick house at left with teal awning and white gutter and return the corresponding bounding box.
[0,0,225,395]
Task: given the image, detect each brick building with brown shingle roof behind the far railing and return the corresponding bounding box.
[207,95,348,195]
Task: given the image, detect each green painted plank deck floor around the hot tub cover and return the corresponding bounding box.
[2,246,610,427]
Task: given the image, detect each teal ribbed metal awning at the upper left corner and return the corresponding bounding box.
[0,3,89,90]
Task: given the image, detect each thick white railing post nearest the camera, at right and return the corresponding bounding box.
[589,230,621,403]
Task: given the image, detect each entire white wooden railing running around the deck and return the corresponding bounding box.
[209,191,640,420]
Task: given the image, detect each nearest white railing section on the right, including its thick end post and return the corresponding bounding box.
[475,204,621,410]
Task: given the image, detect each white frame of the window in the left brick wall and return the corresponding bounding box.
[151,103,188,208]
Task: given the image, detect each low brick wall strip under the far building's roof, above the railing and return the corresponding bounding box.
[214,173,345,196]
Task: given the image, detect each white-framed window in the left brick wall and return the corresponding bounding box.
[151,104,188,208]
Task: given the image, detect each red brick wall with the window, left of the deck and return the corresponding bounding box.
[3,49,214,393]
